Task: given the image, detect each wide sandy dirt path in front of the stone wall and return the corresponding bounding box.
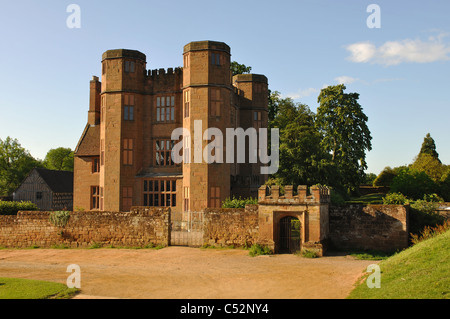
[0,247,374,299]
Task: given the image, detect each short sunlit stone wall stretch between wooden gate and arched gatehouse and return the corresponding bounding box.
[203,205,259,246]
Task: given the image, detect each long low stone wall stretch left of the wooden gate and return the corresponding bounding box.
[0,207,170,248]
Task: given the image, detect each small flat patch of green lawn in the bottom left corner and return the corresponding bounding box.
[0,278,78,299]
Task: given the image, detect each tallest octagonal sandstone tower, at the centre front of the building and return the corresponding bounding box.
[183,41,233,211]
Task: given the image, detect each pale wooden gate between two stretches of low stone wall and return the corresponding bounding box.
[170,212,203,247]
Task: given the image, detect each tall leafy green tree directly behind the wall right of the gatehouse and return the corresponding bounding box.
[315,84,372,192]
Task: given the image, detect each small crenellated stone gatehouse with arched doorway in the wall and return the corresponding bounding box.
[258,185,330,256]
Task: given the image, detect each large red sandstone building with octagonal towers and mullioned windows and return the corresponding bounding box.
[73,41,268,211]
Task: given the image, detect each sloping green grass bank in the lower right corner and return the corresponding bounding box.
[348,230,450,299]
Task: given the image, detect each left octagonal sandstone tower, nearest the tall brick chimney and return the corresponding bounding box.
[99,49,146,211]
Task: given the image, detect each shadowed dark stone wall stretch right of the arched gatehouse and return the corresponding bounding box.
[329,204,409,251]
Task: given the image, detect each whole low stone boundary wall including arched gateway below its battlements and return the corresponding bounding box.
[0,204,409,255]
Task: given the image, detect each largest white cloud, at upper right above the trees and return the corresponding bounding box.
[346,33,450,65]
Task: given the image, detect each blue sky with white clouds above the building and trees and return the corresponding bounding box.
[0,0,450,174]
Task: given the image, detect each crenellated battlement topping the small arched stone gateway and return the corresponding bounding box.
[258,185,330,205]
